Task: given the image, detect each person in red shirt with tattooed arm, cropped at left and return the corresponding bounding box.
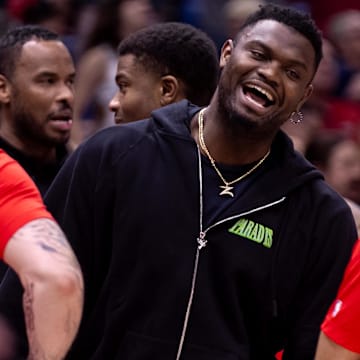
[0,149,83,360]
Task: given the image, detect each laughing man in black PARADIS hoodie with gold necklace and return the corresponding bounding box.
[4,4,357,360]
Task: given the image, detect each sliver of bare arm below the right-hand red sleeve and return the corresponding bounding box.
[315,332,360,360]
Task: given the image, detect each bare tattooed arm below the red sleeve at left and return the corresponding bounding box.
[4,219,83,360]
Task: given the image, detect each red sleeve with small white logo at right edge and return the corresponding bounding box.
[321,241,360,353]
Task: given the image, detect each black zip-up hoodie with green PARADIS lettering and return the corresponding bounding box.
[46,101,356,360]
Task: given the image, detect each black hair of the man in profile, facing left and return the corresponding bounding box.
[118,22,219,106]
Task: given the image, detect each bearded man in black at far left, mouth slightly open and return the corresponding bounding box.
[0,26,75,278]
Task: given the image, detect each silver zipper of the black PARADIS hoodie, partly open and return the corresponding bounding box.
[176,145,286,360]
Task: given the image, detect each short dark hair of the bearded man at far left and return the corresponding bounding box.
[0,25,59,78]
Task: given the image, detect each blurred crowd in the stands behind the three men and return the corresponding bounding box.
[0,0,360,211]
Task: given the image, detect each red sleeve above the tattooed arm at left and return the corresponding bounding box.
[0,150,52,259]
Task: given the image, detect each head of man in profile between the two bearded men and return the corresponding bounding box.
[109,22,219,123]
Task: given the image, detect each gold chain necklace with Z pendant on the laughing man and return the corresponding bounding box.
[198,108,270,197]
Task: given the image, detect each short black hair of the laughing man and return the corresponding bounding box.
[237,4,323,70]
